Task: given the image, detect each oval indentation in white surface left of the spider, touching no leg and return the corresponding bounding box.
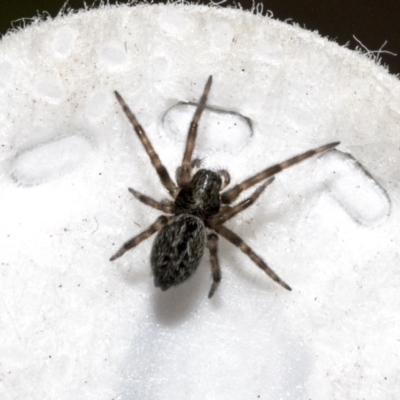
[11,136,92,186]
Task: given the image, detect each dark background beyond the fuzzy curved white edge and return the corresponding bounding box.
[0,0,400,74]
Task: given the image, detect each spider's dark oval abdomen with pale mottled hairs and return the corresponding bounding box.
[150,214,206,290]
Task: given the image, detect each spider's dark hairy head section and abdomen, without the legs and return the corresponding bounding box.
[150,169,222,290]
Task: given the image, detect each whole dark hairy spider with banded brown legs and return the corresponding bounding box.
[110,76,339,298]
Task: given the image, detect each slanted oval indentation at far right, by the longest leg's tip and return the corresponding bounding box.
[321,150,391,226]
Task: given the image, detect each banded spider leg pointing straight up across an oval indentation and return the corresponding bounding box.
[178,76,212,186]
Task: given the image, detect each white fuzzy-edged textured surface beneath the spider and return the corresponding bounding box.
[0,6,400,400]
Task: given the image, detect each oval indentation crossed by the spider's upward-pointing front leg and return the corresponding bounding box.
[162,103,253,153]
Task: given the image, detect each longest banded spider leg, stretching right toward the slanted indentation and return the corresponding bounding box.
[221,142,340,204]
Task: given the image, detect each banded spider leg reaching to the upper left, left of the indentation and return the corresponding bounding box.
[114,91,178,198]
